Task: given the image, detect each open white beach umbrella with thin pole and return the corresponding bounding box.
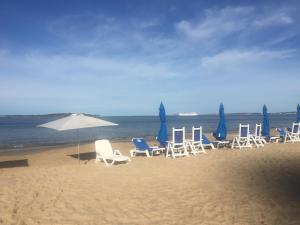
[38,114,118,161]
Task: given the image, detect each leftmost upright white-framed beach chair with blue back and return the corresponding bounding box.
[166,127,189,158]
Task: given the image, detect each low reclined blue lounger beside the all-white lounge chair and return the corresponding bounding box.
[130,138,165,157]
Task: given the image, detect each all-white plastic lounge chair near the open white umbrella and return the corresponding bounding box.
[95,139,130,166]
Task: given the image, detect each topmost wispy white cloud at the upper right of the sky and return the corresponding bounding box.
[175,6,294,42]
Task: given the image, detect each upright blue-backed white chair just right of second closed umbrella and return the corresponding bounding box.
[231,124,252,150]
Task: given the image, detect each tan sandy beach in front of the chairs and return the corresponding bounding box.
[0,142,300,225]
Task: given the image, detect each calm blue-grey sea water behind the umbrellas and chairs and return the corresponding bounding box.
[0,113,296,150]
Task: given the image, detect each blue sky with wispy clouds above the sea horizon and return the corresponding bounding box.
[0,0,300,115]
